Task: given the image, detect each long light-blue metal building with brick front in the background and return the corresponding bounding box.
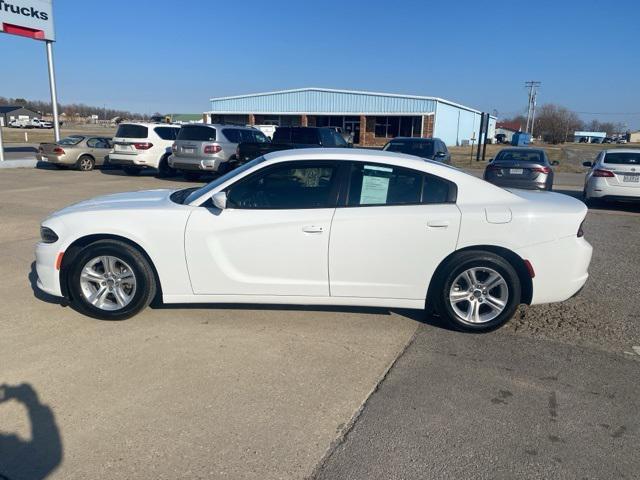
[204,88,496,146]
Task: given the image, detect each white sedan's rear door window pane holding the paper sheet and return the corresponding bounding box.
[348,163,423,206]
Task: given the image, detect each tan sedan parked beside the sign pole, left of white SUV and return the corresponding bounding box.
[36,135,113,172]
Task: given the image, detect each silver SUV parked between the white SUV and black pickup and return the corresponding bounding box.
[169,124,269,178]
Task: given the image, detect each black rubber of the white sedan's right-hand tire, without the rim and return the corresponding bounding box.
[433,250,522,333]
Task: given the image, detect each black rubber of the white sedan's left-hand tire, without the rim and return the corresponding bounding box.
[66,240,157,320]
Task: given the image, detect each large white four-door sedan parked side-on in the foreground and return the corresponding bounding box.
[36,149,592,331]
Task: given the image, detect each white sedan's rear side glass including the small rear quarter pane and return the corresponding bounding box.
[347,163,457,207]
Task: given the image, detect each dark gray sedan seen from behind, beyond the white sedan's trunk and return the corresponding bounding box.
[484,147,558,190]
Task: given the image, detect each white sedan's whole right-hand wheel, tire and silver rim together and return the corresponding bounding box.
[437,250,521,332]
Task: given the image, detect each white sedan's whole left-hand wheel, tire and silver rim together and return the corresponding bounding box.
[67,240,156,320]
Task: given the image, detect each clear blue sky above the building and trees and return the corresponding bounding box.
[0,0,640,128]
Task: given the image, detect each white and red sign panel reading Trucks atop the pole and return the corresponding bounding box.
[0,0,56,41]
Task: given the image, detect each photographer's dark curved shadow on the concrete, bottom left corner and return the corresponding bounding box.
[0,383,63,480]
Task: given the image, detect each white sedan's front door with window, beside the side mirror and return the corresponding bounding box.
[185,161,338,297]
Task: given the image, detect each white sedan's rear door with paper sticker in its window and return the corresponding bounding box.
[329,162,460,299]
